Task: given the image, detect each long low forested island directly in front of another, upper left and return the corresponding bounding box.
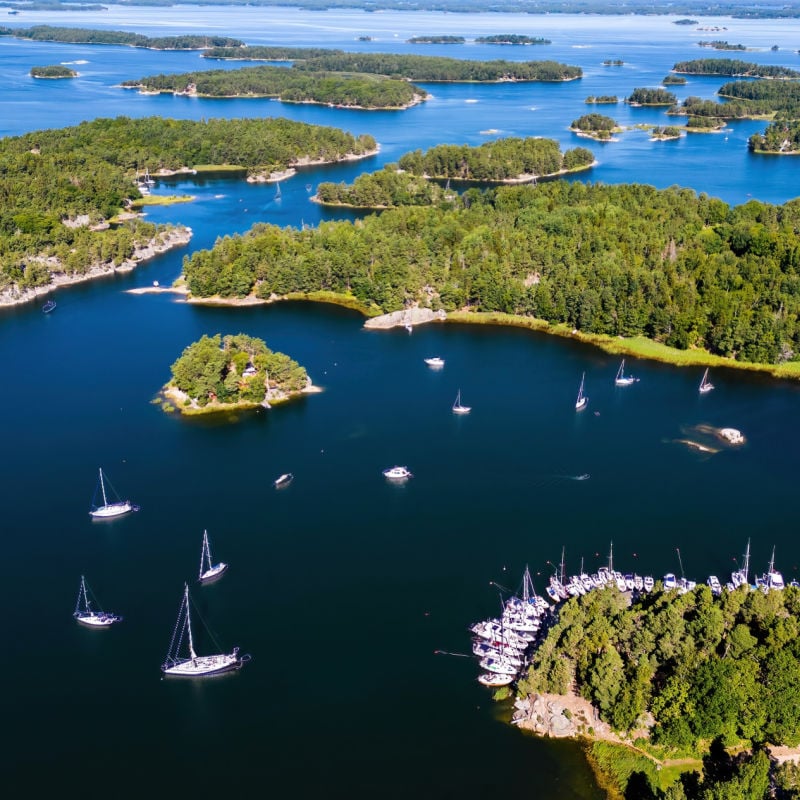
[122,66,428,109]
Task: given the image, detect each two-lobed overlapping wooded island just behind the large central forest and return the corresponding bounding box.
[316,138,594,209]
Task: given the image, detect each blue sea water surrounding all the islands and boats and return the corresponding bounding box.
[0,7,800,800]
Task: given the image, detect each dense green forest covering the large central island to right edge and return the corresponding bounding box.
[184,181,800,364]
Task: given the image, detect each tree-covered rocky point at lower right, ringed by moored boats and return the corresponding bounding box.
[512,582,800,800]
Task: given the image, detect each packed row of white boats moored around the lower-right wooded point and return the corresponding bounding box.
[470,539,800,687]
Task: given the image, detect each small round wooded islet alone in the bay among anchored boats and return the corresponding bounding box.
[161,333,317,416]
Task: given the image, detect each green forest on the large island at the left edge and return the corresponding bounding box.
[0,117,375,290]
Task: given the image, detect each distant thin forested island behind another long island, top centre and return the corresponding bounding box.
[295,53,583,82]
